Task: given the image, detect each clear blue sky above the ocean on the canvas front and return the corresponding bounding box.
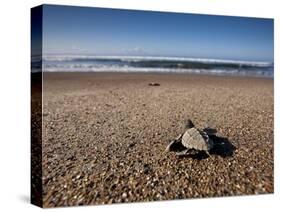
[43,5,274,61]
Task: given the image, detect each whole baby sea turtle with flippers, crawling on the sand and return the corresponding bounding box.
[166,119,216,155]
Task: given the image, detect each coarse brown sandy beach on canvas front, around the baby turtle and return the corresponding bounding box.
[42,73,274,207]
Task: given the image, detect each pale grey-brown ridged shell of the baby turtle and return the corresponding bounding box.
[182,127,213,151]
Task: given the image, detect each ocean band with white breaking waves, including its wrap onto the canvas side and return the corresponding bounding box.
[32,55,274,78]
